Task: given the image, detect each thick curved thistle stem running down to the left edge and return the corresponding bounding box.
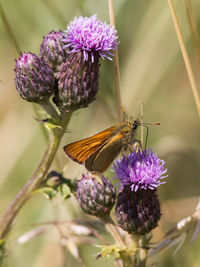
[0,113,72,238]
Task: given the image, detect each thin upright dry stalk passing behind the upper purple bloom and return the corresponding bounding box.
[108,0,122,122]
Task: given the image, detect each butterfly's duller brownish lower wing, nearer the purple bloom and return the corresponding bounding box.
[85,133,124,172]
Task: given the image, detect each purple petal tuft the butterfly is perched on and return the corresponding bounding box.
[113,149,168,192]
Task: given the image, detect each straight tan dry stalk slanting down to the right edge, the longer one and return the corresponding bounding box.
[168,0,200,116]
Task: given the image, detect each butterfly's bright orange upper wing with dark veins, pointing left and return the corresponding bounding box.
[63,126,118,164]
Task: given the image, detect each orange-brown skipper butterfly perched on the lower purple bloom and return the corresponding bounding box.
[63,120,143,173]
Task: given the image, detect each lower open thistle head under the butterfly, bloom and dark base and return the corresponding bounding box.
[113,149,167,235]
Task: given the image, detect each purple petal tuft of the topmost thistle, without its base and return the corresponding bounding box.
[64,15,118,62]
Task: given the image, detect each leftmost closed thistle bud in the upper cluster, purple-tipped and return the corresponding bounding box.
[14,52,55,103]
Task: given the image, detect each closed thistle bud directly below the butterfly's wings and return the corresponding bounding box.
[76,173,116,218]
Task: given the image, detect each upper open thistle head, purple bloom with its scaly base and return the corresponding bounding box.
[57,15,117,110]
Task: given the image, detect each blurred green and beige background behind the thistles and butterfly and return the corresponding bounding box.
[0,0,200,267]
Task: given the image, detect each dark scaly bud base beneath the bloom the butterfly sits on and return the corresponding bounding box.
[115,186,161,235]
